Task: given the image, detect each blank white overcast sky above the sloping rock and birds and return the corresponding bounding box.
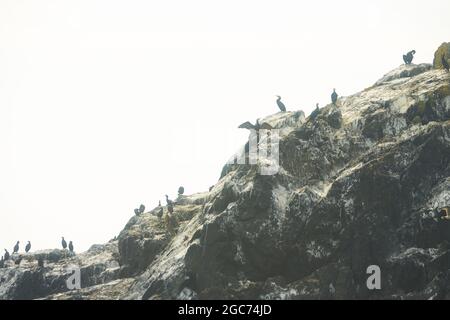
[0,0,450,251]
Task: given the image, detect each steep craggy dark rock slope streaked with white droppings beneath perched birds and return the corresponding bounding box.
[0,56,450,299]
